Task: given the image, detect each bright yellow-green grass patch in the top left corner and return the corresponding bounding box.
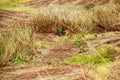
[0,0,36,12]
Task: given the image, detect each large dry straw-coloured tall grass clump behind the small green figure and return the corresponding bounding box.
[33,5,94,33]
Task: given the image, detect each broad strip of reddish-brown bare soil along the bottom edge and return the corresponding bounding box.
[0,65,93,80]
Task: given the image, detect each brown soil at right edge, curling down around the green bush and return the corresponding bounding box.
[87,32,120,60]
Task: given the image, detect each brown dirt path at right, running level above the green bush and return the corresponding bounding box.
[87,32,120,49]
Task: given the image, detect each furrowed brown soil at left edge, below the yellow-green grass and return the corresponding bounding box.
[0,10,32,28]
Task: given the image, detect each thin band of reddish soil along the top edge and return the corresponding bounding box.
[23,0,116,7]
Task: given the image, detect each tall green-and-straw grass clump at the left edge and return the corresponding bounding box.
[0,29,35,66]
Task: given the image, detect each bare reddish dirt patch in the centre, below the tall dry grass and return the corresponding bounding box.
[34,33,79,65]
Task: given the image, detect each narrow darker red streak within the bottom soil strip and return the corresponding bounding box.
[12,66,80,79]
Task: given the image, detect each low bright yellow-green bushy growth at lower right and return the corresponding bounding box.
[65,46,115,65]
